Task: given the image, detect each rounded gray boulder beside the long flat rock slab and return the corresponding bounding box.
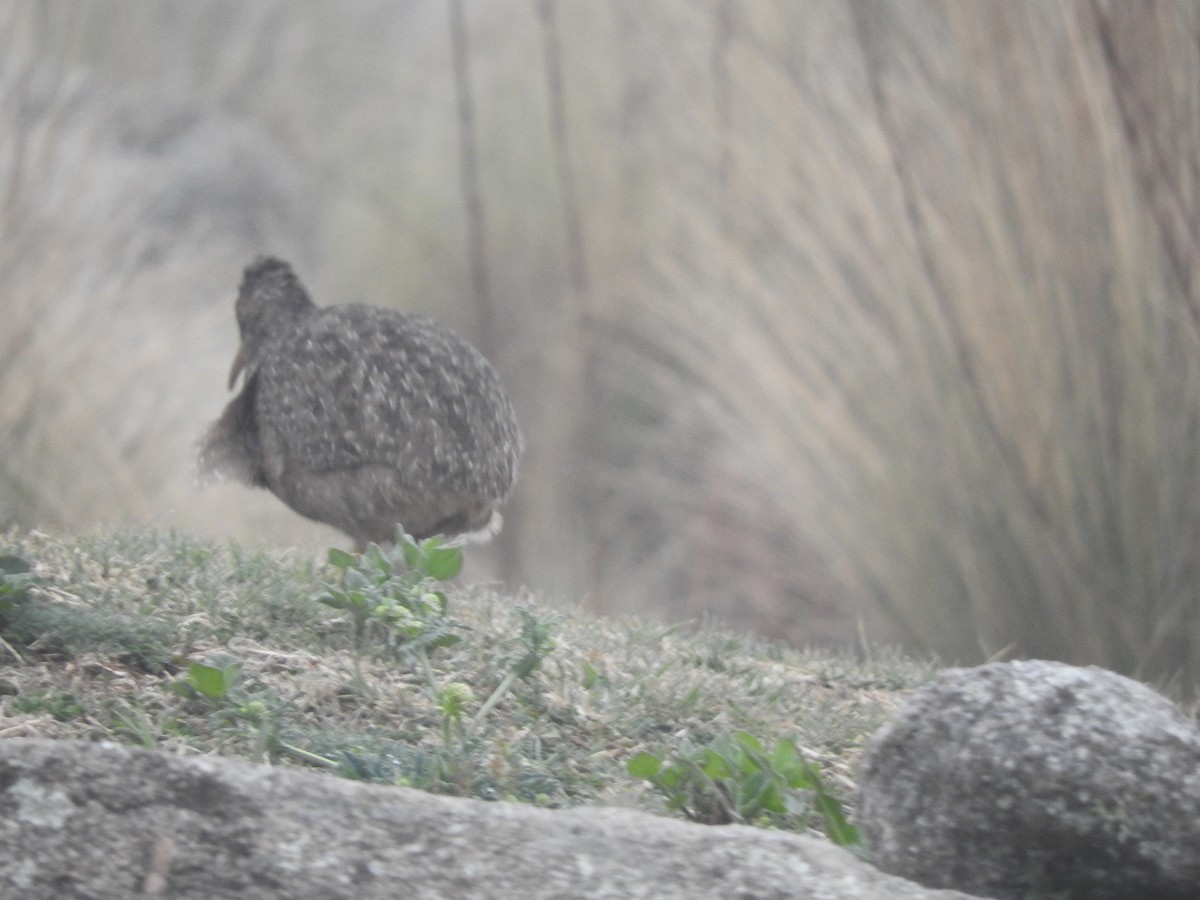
[858,661,1200,900]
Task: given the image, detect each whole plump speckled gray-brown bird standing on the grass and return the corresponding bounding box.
[199,257,521,547]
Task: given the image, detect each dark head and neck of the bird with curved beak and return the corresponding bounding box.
[229,257,317,389]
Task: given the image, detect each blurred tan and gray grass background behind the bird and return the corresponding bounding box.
[0,0,1200,685]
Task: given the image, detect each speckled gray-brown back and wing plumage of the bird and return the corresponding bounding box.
[253,305,520,500]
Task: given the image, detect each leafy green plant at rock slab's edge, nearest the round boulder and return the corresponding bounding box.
[626,731,859,847]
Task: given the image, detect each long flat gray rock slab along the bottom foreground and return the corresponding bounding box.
[0,739,962,900]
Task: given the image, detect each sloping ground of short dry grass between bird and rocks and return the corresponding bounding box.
[0,532,932,844]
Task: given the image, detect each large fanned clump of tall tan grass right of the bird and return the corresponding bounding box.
[595,4,1200,684]
